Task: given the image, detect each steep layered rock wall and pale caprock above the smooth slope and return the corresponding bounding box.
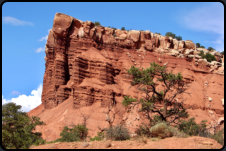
[42,13,222,109]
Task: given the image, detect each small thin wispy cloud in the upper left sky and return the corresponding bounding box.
[2,16,34,26]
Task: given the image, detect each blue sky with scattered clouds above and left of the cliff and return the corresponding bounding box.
[2,2,224,112]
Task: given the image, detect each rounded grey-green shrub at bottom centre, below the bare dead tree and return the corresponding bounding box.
[106,125,130,141]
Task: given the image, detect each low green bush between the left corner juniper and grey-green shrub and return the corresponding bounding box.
[54,124,88,142]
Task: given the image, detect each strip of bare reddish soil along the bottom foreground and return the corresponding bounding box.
[31,136,223,149]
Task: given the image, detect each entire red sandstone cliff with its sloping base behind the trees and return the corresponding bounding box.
[29,13,224,140]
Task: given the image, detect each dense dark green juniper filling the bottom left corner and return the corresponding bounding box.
[2,102,45,149]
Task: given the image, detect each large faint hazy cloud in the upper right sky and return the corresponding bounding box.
[180,3,224,51]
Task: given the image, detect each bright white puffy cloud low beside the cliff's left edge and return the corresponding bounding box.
[2,84,42,112]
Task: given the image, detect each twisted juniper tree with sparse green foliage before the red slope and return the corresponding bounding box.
[122,62,189,123]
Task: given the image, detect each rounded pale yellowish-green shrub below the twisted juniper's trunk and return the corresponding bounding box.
[150,123,173,139]
